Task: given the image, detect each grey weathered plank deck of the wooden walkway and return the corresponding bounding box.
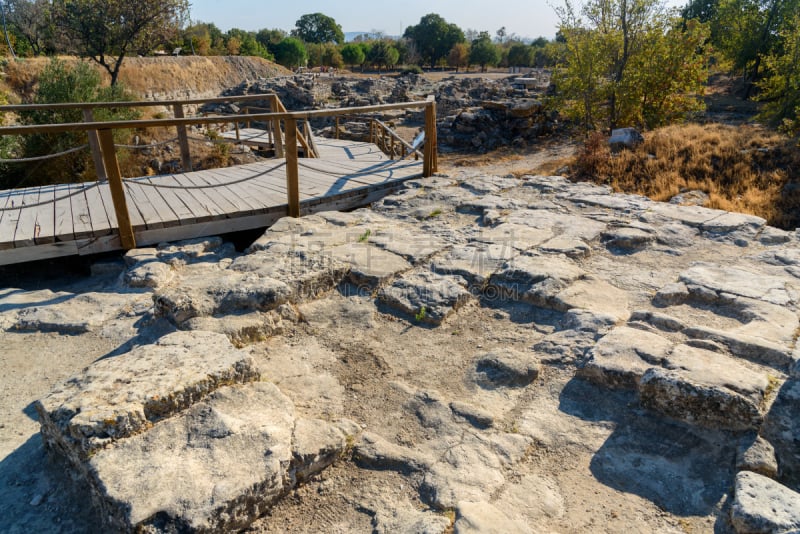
[0,139,423,265]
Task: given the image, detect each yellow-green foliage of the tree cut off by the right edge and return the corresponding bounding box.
[759,14,800,134]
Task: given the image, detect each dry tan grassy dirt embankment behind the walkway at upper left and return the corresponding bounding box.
[4,56,291,102]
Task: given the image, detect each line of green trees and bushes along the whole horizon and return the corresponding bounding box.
[0,0,800,136]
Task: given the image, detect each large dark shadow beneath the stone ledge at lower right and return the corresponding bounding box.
[560,379,737,516]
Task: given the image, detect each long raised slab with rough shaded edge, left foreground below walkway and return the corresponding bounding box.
[36,332,259,465]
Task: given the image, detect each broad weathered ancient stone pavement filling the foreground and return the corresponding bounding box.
[0,173,800,533]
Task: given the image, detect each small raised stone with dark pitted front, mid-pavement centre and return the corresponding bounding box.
[378,271,473,326]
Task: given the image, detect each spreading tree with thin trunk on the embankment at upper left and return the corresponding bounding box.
[53,0,189,85]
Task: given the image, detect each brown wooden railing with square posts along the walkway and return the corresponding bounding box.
[0,95,438,249]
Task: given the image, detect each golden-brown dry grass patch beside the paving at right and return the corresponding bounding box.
[573,124,800,228]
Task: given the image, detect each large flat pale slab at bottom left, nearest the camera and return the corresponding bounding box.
[87,383,295,532]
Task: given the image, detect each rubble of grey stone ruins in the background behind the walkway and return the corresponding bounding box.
[206,71,557,152]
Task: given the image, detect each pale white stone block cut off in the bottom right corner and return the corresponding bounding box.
[731,471,800,534]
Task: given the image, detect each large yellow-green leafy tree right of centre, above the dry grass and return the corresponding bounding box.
[554,0,708,129]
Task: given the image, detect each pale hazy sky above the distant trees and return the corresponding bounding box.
[190,0,562,38]
